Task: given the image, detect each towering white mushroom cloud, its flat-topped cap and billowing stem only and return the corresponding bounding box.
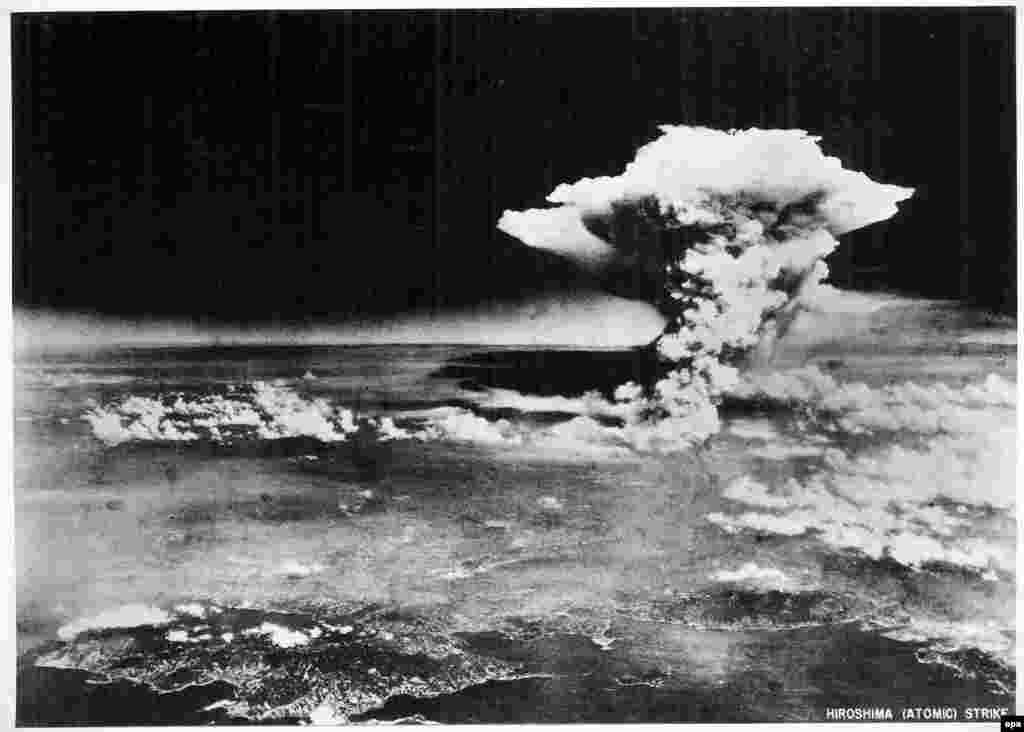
[498,126,913,446]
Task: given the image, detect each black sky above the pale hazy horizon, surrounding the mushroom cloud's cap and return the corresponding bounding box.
[13,8,1016,321]
